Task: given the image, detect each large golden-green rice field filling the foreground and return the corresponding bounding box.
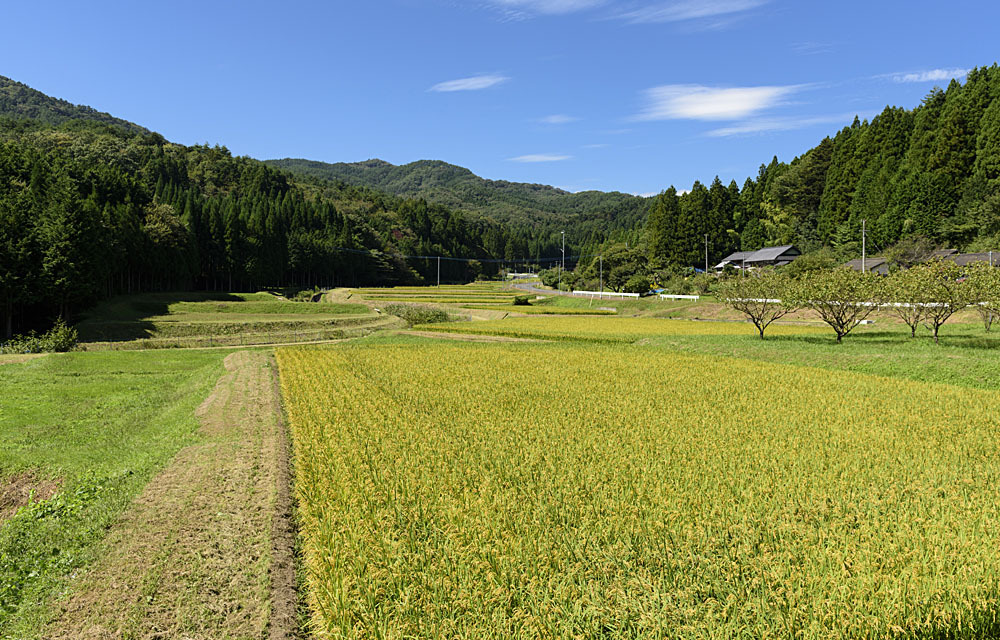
[278,342,1000,639]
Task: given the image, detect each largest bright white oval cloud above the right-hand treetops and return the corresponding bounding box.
[635,84,802,120]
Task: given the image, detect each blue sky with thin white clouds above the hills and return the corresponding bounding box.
[0,0,1000,193]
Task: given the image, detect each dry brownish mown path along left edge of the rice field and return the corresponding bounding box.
[42,351,297,640]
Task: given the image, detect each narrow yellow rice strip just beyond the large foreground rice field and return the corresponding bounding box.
[419,317,829,342]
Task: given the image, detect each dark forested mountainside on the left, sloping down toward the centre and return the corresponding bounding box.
[0,79,584,336]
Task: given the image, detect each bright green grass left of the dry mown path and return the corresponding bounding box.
[0,351,225,637]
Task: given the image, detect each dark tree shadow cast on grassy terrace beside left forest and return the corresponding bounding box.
[76,291,243,342]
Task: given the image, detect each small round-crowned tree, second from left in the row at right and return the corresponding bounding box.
[789,267,885,342]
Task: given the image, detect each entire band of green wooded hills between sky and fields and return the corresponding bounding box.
[0,64,1000,336]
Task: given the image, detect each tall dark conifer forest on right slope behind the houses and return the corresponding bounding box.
[646,64,1000,266]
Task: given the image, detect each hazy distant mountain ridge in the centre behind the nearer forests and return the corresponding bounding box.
[264,158,649,223]
